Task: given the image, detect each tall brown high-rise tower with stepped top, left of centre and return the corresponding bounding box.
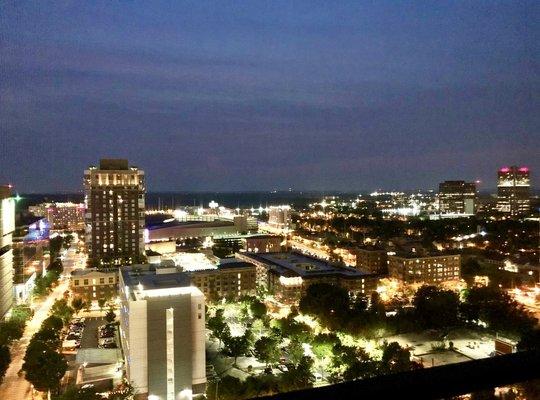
[84,159,145,266]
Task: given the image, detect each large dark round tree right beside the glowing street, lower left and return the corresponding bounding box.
[22,340,67,392]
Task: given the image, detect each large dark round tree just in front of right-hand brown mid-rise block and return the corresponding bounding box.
[413,286,459,329]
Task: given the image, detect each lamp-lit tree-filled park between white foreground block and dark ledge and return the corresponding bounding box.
[207,284,535,400]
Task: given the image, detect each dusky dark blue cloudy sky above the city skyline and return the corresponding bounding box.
[0,1,540,192]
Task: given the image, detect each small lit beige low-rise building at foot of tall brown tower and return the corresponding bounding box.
[70,268,118,301]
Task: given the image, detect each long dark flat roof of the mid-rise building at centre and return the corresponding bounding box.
[245,251,372,278]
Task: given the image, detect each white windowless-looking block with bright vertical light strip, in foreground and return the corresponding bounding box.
[119,265,206,400]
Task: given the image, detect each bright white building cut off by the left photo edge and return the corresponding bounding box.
[0,186,15,319]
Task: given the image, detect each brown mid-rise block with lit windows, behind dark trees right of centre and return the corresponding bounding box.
[388,253,461,284]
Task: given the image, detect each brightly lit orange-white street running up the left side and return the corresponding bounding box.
[0,242,83,400]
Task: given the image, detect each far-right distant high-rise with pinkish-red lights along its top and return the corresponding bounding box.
[497,165,531,216]
